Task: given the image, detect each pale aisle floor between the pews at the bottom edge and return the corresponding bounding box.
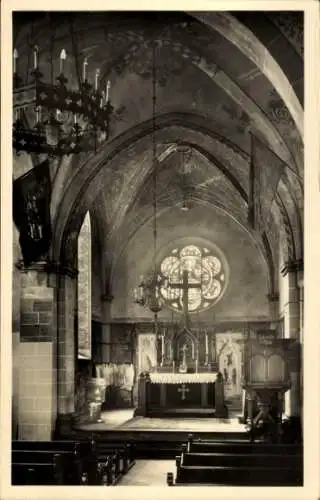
[119,460,175,486]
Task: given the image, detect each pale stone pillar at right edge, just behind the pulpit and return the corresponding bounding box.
[281,261,303,417]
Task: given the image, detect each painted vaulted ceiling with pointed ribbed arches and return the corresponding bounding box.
[14,12,304,292]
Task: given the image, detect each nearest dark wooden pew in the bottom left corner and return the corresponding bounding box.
[11,454,64,486]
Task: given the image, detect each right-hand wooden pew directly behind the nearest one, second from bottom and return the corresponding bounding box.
[176,453,303,469]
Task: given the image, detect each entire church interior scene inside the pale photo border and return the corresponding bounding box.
[11,11,304,486]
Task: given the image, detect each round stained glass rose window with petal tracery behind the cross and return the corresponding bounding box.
[159,245,226,312]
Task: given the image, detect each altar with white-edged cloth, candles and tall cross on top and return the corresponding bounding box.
[135,270,226,418]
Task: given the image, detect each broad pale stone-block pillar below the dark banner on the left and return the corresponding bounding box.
[17,262,57,441]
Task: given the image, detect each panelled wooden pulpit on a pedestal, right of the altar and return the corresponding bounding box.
[243,331,292,438]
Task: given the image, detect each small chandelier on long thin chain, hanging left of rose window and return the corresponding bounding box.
[133,41,162,318]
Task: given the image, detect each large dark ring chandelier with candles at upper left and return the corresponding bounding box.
[13,20,113,157]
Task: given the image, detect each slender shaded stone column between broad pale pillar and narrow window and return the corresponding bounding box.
[56,266,77,432]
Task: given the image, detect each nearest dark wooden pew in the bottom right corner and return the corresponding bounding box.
[167,465,303,486]
